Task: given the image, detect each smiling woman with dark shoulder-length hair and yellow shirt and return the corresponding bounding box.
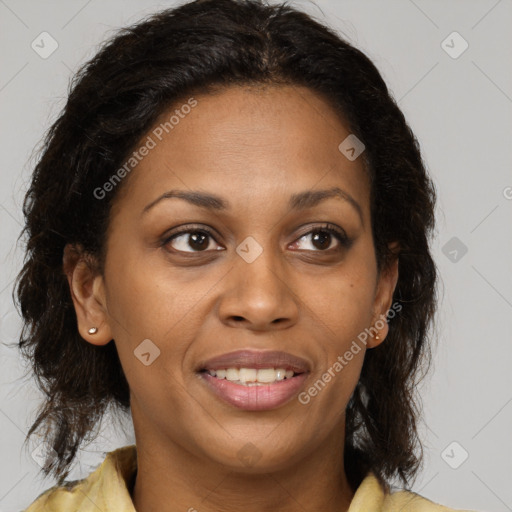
[17,0,476,512]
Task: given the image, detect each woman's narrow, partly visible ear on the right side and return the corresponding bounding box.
[367,242,399,348]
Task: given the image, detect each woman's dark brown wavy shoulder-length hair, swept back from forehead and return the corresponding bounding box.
[15,0,437,489]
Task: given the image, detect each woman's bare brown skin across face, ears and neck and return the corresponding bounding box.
[65,86,398,512]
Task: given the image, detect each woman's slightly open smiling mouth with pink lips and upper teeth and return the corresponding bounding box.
[198,350,310,411]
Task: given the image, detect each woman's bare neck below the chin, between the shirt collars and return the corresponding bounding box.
[133,429,354,512]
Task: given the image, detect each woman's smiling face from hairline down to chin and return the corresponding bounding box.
[79,86,397,472]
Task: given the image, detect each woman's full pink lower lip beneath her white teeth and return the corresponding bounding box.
[200,372,307,411]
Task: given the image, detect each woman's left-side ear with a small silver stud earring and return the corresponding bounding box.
[63,244,112,345]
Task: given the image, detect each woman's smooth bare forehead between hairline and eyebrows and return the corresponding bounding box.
[112,86,369,220]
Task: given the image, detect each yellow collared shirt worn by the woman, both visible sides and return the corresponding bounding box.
[21,445,476,512]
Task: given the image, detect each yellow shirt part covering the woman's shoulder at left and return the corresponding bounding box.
[25,445,136,512]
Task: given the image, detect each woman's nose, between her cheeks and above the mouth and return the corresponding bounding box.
[218,244,299,331]
